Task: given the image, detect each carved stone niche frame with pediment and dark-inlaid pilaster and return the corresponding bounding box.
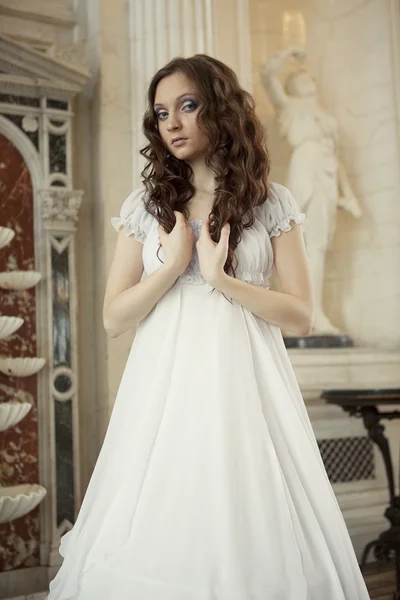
[0,32,90,589]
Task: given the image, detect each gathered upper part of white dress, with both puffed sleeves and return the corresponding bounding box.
[112,183,305,287]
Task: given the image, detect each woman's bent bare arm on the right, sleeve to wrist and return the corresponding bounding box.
[213,223,314,335]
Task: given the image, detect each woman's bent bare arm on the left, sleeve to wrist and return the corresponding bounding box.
[103,231,179,337]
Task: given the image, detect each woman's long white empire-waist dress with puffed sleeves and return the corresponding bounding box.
[48,184,369,600]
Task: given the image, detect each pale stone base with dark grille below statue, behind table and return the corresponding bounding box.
[288,348,400,560]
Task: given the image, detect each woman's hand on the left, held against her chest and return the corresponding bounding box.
[158,211,195,277]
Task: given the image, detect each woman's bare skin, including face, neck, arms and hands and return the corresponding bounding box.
[103,73,313,337]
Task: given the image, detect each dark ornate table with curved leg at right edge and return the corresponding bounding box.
[321,388,400,600]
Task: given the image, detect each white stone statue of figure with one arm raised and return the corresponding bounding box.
[261,47,362,335]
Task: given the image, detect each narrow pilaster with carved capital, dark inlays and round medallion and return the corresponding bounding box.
[40,186,83,573]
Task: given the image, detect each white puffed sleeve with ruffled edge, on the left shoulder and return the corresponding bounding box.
[111,187,152,244]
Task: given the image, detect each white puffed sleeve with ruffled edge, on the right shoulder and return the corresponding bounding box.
[260,183,306,237]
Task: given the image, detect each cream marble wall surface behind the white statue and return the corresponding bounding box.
[250,0,400,348]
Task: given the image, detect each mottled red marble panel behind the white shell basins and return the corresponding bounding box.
[0,134,40,571]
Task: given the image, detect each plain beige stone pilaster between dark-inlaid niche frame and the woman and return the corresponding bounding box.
[74,0,132,450]
